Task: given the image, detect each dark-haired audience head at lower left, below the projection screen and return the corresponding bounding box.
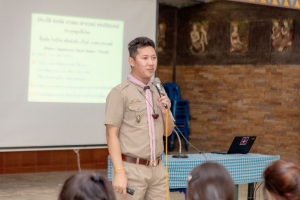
[58,171,115,200]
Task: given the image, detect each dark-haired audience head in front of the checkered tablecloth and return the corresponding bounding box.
[187,162,235,200]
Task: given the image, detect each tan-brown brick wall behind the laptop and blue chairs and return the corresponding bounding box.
[158,65,300,160]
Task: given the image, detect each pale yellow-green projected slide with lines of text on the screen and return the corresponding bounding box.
[28,13,124,103]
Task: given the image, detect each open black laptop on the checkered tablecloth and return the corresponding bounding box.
[211,136,256,154]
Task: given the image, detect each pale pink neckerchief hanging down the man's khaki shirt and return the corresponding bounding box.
[127,74,156,166]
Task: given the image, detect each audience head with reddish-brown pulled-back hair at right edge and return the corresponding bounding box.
[263,160,300,200]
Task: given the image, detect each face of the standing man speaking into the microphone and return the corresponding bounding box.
[128,46,157,84]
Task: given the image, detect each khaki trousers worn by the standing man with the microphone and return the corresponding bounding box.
[113,161,170,200]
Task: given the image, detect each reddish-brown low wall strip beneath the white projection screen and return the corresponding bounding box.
[0,148,108,174]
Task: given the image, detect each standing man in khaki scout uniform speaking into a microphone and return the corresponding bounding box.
[104,37,174,200]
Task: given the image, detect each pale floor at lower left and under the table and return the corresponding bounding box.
[0,170,263,200]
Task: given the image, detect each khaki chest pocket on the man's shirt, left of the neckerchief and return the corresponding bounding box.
[125,103,148,126]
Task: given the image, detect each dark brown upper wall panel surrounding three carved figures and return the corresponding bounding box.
[177,1,300,65]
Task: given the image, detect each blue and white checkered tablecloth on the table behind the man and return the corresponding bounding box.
[107,153,279,189]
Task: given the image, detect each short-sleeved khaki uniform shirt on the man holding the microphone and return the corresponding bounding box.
[104,80,166,159]
